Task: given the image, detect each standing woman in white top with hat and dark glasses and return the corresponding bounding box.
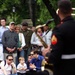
[31,25,44,50]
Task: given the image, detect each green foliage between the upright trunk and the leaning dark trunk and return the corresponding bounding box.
[37,0,51,24]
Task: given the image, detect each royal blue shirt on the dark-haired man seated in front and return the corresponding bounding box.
[31,55,44,70]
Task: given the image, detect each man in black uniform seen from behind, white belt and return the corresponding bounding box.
[45,0,75,75]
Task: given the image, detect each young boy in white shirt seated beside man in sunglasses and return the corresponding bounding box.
[17,57,27,75]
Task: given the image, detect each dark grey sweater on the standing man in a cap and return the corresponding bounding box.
[2,30,18,53]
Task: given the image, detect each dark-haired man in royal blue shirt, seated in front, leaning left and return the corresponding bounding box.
[30,51,44,71]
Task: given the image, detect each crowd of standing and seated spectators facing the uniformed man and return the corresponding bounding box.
[0,14,53,75]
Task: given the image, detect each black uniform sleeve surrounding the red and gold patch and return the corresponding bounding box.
[49,27,64,64]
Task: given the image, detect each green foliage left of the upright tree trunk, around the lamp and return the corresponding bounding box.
[0,0,29,23]
